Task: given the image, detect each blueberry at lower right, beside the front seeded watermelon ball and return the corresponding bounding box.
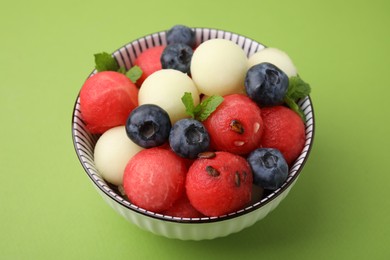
[247,148,288,190]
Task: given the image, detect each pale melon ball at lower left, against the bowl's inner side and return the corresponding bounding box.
[94,126,143,186]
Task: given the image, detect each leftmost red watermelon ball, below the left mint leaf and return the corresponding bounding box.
[80,71,138,134]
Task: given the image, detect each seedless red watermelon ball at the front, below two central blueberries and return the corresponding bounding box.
[123,147,187,213]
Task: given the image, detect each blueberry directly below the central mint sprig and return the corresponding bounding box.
[169,118,210,159]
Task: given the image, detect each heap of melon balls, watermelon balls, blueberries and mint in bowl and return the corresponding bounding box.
[80,25,310,218]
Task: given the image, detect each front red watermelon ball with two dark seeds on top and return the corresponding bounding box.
[186,152,253,217]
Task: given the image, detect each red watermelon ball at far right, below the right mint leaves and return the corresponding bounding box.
[260,106,306,165]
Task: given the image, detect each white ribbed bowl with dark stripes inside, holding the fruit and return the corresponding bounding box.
[72,28,315,240]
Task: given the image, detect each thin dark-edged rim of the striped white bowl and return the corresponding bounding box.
[71,27,315,224]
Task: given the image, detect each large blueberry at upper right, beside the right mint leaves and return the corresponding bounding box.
[245,62,288,107]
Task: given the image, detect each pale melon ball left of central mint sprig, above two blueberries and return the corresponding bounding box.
[138,69,199,124]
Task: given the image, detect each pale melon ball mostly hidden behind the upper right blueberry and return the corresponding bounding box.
[248,48,298,77]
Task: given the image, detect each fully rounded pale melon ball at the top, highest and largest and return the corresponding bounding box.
[191,39,248,96]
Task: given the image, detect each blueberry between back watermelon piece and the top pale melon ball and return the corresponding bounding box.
[160,43,194,73]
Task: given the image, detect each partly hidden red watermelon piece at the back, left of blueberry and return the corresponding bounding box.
[134,46,165,87]
